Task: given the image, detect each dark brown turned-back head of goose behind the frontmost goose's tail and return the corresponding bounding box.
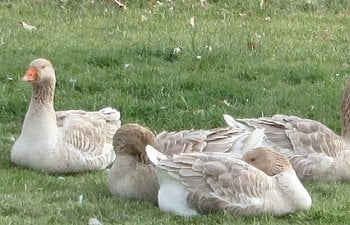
[113,124,155,163]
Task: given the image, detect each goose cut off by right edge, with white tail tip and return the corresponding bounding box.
[224,79,350,181]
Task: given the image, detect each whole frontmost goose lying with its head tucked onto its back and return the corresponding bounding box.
[146,145,312,217]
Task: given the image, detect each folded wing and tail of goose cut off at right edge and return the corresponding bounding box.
[225,114,347,157]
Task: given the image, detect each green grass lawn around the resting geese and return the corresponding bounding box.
[0,0,350,224]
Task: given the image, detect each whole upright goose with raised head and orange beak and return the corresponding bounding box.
[10,59,120,174]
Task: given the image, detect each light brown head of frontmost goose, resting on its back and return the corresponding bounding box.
[242,147,293,176]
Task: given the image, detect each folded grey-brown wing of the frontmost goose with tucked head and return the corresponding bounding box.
[159,153,274,215]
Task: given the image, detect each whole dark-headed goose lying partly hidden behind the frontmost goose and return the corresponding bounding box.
[108,123,264,203]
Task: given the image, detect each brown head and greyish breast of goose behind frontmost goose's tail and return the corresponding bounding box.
[108,124,158,203]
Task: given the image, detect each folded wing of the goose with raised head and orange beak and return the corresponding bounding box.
[56,108,120,167]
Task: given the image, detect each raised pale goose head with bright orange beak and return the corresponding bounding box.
[22,59,56,84]
